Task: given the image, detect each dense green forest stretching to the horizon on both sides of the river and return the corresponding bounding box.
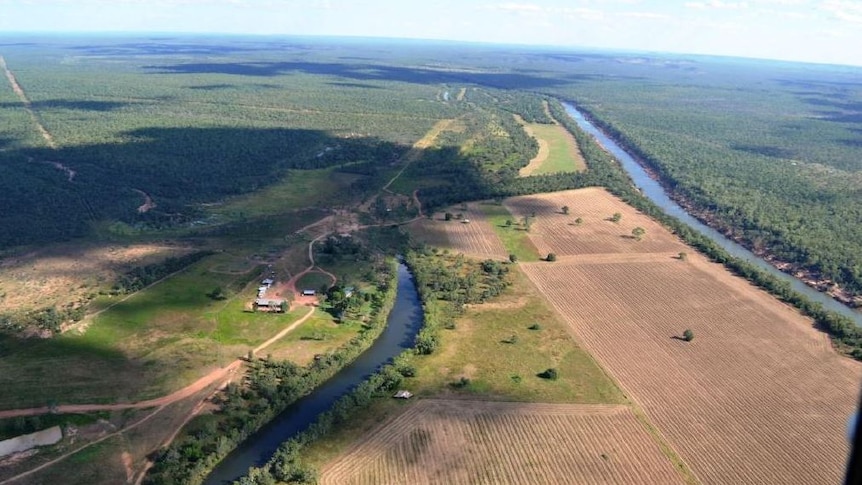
[0,37,862,304]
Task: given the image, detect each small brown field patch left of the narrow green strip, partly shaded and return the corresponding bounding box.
[411,203,509,259]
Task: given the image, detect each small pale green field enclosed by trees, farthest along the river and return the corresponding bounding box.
[518,119,587,177]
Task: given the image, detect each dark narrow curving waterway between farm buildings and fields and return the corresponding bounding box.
[204,263,423,485]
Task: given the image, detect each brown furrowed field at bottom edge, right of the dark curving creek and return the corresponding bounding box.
[320,400,683,485]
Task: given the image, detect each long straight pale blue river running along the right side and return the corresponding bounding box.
[563,103,862,326]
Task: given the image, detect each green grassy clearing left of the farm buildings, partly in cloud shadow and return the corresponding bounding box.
[0,246,310,409]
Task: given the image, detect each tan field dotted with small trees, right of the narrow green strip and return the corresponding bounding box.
[504,188,691,257]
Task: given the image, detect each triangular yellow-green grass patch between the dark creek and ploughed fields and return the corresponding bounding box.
[305,269,626,467]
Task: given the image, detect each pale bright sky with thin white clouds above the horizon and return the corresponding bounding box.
[0,0,862,66]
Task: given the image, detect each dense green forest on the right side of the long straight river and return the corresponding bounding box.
[560,59,862,303]
